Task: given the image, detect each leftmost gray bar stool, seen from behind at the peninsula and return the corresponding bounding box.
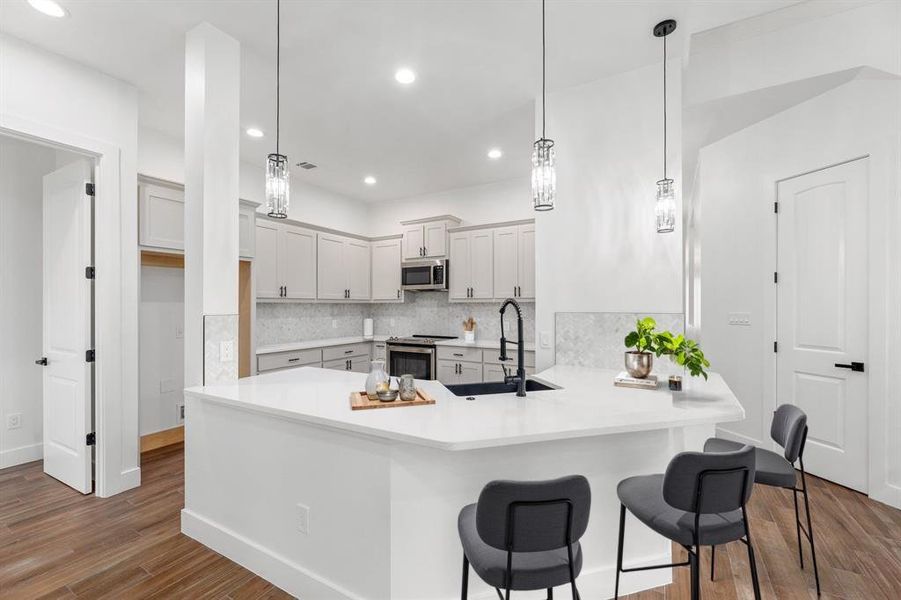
[457,475,591,600]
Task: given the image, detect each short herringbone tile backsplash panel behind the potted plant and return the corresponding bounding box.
[554,313,684,375]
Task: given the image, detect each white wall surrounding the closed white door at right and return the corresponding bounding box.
[700,80,901,505]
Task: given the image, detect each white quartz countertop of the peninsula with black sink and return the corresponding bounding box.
[185,366,745,450]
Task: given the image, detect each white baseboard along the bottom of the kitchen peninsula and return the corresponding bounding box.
[181,509,672,600]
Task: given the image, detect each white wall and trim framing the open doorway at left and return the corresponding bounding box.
[0,36,141,496]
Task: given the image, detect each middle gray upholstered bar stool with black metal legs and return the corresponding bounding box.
[614,446,760,600]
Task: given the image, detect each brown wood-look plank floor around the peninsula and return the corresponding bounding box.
[0,446,901,600]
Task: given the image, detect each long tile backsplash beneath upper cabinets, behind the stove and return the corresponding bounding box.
[256,292,535,346]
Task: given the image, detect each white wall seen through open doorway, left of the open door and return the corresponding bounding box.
[0,136,56,468]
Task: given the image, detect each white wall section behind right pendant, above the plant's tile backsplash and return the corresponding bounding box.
[533,60,682,368]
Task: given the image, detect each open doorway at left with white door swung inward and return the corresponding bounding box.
[0,136,94,494]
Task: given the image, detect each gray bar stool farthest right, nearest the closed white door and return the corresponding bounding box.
[704,404,820,596]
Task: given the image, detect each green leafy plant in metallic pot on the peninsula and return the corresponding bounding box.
[625,317,710,379]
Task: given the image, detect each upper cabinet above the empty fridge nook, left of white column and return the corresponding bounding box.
[138,183,185,250]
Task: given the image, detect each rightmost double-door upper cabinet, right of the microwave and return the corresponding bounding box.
[494,223,535,300]
